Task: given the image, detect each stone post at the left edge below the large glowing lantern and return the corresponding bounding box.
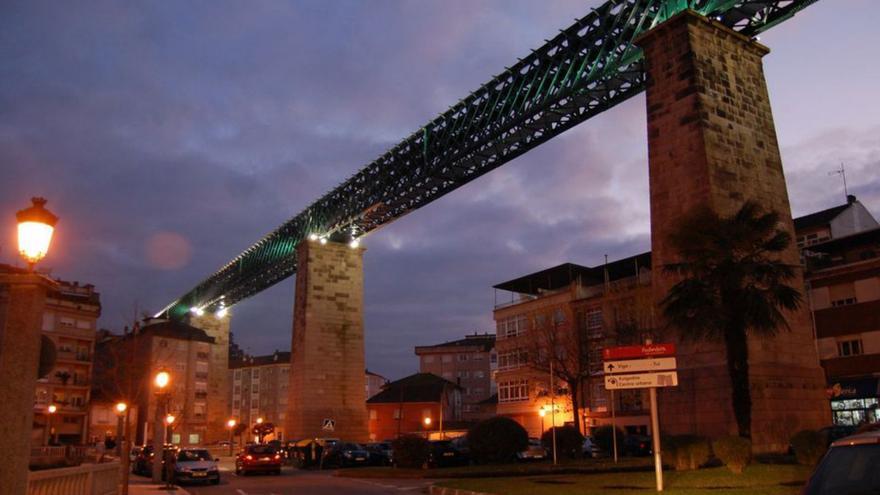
[0,274,54,495]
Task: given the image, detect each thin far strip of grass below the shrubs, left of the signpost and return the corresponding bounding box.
[337,457,653,479]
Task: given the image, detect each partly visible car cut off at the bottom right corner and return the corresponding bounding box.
[801,431,880,495]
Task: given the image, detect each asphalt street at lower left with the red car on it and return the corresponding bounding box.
[133,467,431,495]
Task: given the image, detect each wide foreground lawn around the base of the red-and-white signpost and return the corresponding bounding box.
[438,464,809,495]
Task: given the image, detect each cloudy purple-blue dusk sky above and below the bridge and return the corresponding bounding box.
[0,0,880,377]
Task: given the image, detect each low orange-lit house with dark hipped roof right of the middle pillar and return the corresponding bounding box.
[367,373,462,441]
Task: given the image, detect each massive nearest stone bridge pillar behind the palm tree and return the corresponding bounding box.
[636,11,830,452]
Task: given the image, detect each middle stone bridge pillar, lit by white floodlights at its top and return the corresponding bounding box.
[286,241,369,441]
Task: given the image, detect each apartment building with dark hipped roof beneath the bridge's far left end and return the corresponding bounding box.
[95,318,217,446]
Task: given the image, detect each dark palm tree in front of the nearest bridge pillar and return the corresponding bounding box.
[660,201,802,438]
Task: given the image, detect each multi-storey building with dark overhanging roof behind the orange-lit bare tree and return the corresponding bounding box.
[494,253,653,436]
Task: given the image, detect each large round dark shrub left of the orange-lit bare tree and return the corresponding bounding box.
[467,416,529,463]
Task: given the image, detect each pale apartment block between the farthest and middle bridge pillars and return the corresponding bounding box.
[229,351,290,440]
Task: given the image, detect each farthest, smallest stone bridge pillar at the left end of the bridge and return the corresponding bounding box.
[189,311,232,443]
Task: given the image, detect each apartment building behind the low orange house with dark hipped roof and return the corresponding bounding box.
[415,332,497,420]
